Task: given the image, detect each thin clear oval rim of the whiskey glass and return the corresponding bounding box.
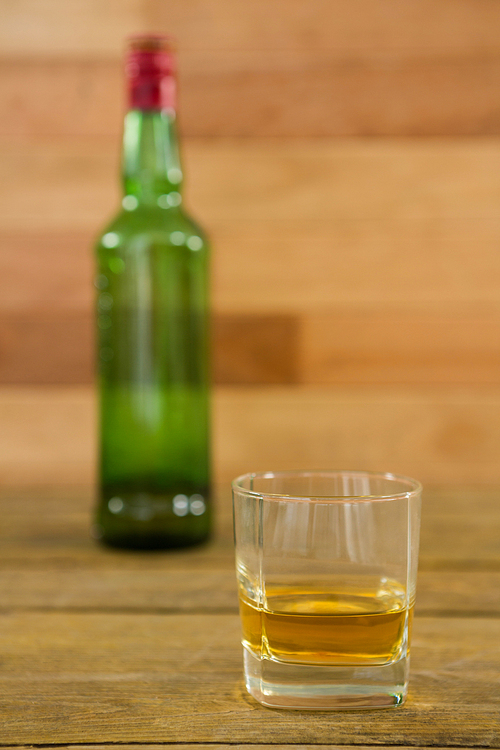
[231,469,422,503]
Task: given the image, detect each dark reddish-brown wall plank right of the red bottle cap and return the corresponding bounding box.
[180,53,500,136]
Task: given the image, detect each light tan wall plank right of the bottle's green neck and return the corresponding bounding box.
[186,138,500,226]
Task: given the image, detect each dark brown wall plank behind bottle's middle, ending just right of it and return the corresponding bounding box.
[0,312,299,385]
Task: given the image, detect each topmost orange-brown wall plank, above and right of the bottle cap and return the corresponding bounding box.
[144,0,500,56]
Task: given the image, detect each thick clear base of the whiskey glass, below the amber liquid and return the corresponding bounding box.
[243,647,409,710]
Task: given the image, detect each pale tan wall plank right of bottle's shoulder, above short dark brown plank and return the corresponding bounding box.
[214,219,500,314]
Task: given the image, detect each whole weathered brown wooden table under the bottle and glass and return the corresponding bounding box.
[0,488,500,748]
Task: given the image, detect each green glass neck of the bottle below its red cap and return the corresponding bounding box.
[122,109,182,208]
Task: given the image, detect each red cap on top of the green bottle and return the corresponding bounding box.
[125,34,176,110]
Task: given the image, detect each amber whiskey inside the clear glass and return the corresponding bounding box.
[240,582,413,665]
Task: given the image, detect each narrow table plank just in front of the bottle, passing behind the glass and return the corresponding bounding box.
[0,568,500,617]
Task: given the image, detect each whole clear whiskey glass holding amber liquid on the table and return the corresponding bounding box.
[232,471,422,709]
